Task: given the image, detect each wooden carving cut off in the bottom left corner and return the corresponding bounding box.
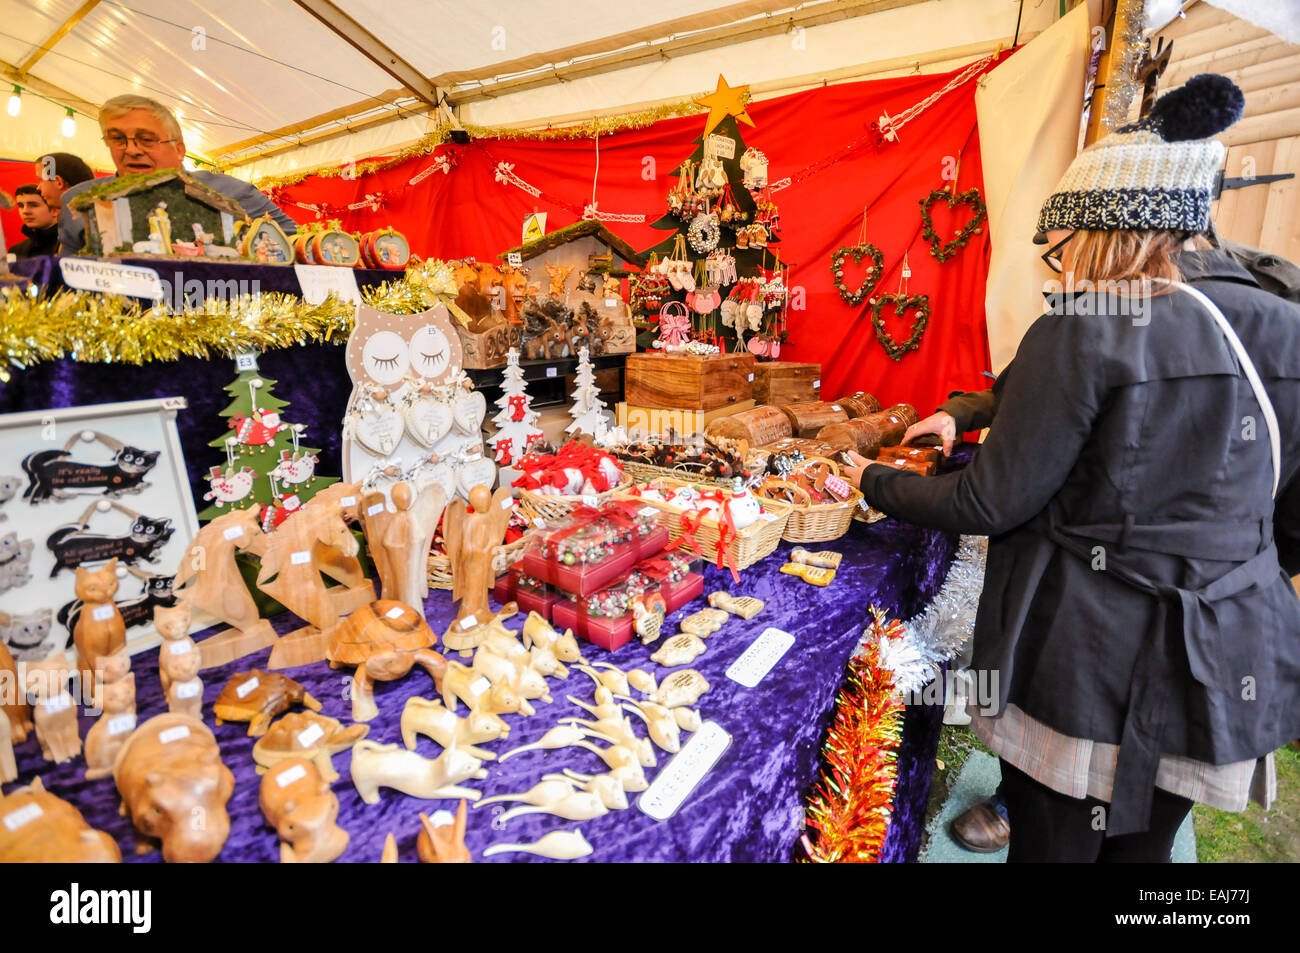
[0,780,122,863]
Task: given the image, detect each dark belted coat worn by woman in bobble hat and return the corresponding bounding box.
[862,251,1300,835]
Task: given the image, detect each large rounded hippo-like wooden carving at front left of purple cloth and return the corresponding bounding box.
[113,712,235,863]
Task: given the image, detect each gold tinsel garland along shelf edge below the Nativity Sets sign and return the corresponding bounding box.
[0,261,460,382]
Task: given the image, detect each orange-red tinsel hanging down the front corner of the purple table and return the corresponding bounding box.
[803,606,902,863]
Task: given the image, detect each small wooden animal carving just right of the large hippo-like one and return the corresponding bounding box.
[257,758,348,863]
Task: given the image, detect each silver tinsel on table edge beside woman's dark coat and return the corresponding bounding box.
[867,536,988,693]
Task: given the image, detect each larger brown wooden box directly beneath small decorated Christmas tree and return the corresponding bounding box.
[624,354,754,411]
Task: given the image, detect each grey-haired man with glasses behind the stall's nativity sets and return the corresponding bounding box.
[59,95,298,255]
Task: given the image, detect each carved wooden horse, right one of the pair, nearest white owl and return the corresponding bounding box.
[257,495,360,668]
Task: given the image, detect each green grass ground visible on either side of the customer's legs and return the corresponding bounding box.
[926,725,1300,863]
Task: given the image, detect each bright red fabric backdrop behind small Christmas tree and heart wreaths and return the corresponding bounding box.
[277,61,989,413]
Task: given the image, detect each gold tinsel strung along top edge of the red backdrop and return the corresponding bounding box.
[244,99,709,191]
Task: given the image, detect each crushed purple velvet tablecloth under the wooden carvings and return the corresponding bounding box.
[5,520,956,862]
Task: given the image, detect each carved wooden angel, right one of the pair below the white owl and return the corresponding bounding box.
[442,485,511,651]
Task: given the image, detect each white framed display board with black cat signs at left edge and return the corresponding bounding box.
[0,398,199,662]
